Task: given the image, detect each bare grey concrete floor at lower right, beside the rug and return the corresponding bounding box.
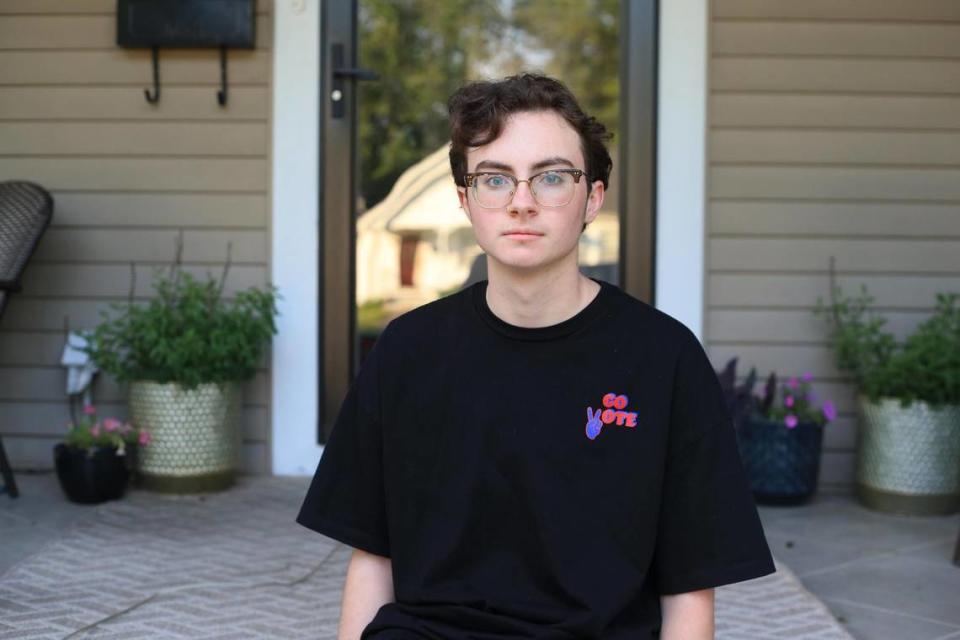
[758,492,960,640]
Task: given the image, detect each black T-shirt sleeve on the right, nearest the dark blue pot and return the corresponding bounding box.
[652,328,776,595]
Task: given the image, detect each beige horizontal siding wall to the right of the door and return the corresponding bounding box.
[706,0,960,487]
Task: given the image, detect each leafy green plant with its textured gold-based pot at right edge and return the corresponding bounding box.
[814,258,960,515]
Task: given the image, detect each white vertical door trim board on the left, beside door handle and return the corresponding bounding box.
[270,0,323,475]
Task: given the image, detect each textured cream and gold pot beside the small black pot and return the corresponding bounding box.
[129,380,241,493]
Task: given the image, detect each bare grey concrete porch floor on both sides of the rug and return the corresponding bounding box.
[0,473,960,640]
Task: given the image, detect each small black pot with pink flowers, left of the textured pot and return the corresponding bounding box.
[53,404,150,504]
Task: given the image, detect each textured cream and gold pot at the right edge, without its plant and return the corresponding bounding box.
[856,394,960,515]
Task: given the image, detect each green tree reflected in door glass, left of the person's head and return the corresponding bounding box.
[358,0,503,205]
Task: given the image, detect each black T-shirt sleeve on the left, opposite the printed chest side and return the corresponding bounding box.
[296,322,390,557]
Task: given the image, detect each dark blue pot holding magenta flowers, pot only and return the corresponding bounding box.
[737,416,823,504]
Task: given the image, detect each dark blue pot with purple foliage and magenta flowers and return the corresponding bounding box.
[718,358,837,505]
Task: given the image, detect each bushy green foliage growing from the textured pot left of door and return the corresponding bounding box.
[81,232,282,389]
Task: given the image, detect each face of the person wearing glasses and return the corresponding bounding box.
[457,111,603,270]
